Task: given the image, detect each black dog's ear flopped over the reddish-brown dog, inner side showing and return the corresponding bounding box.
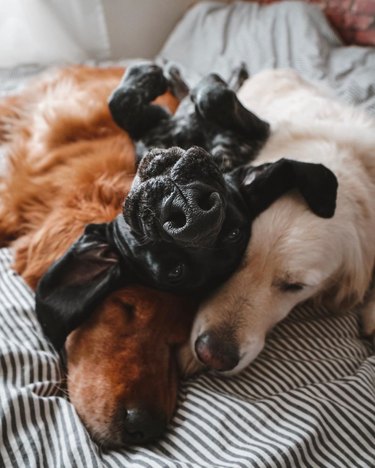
[35,224,122,349]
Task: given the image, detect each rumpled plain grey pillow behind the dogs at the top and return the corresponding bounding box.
[158,2,375,114]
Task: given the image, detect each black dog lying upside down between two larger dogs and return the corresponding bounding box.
[36,64,337,348]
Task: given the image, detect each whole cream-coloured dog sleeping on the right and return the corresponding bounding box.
[183,70,375,374]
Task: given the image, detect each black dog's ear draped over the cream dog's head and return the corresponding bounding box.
[240,159,338,218]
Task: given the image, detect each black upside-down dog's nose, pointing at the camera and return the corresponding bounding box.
[161,182,225,247]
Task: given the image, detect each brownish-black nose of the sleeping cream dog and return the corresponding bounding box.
[195,332,240,371]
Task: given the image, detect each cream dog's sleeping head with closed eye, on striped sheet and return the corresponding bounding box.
[183,184,374,374]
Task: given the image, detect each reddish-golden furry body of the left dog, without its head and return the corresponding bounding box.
[0,67,177,287]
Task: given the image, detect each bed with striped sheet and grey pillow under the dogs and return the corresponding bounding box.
[0,2,375,468]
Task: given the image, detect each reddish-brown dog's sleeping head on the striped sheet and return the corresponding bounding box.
[66,287,194,447]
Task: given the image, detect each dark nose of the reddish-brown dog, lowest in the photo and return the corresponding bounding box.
[122,409,167,444]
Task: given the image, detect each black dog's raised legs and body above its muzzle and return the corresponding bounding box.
[109,62,269,172]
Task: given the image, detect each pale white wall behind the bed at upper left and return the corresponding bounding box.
[0,0,197,67]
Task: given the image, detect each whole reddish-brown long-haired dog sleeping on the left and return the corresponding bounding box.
[0,67,194,446]
